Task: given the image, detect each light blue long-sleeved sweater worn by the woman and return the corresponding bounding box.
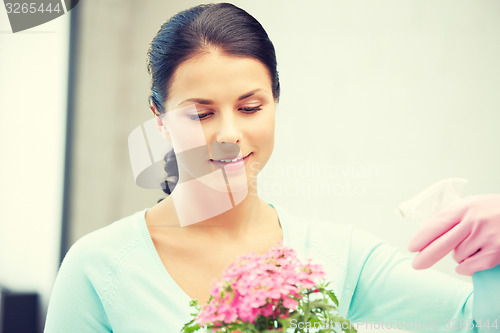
[45,206,476,333]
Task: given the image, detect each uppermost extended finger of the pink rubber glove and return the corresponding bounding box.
[408,200,467,252]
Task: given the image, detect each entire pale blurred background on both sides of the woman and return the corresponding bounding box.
[0,0,500,327]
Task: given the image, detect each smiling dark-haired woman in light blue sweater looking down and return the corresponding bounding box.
[45,4,500,332]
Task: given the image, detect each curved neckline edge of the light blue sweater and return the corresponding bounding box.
[138,204,289,307]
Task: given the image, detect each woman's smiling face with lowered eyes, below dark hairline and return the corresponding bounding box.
[165,50,275,191]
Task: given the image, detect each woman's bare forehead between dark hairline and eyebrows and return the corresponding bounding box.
[167,51,272,105]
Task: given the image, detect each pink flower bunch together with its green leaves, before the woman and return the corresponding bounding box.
[182,243,356,333]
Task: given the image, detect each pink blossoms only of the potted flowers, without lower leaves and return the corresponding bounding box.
[192,243,325,327]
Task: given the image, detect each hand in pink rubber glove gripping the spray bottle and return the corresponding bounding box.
[408,194,500,275]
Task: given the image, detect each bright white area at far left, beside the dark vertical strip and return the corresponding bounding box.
[0,9,70,330]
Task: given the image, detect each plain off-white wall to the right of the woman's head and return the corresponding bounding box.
[234,0,500,281]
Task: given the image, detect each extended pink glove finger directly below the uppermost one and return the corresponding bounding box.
[412,220,470,269]
